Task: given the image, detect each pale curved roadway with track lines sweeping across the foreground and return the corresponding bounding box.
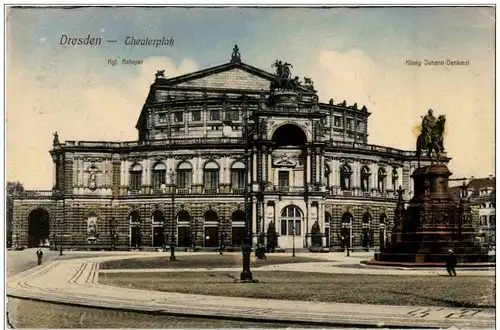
[7,256,495,328]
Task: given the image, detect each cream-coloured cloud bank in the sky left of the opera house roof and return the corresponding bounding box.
[6,57,198,189]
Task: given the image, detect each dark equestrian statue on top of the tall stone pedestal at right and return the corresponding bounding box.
[417,109,446,167]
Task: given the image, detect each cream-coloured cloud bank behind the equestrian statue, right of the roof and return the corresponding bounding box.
[313,50,495,177]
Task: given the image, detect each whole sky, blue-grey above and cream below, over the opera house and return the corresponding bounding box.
[7,7,495,188]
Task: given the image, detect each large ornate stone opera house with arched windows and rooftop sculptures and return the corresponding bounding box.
[13,47,440,249]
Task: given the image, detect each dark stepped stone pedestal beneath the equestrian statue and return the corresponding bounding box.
[371,164,488,264]
